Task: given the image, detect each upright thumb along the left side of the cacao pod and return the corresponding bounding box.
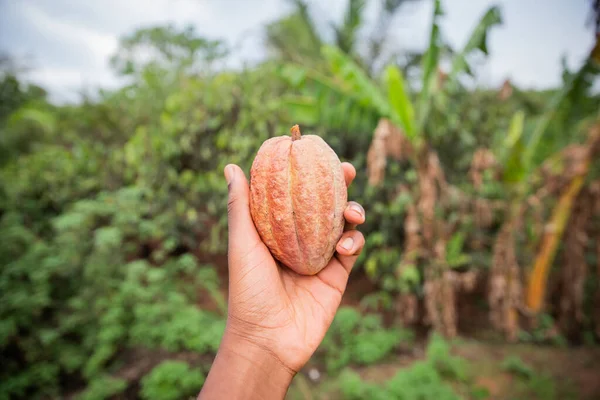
[225,164,258,249]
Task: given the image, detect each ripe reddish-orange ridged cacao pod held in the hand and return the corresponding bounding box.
[250,125,348,275]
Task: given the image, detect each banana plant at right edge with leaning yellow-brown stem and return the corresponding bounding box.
[497,39,600,314]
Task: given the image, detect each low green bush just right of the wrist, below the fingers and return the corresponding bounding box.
[318,307,412,374]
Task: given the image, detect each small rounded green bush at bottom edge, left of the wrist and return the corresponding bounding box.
[140,361,205,400]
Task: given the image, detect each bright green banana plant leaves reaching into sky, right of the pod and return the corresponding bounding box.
[281,0,502,145]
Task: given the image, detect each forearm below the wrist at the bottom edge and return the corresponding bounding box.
[198,332,295,400]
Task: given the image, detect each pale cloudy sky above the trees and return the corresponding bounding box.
[0,0,594,102]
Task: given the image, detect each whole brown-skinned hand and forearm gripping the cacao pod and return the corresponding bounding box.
[198,163,365,400]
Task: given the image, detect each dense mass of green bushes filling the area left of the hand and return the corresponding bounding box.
[0,23,288,399]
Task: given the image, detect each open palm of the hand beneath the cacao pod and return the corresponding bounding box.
[232,238,348,369]
